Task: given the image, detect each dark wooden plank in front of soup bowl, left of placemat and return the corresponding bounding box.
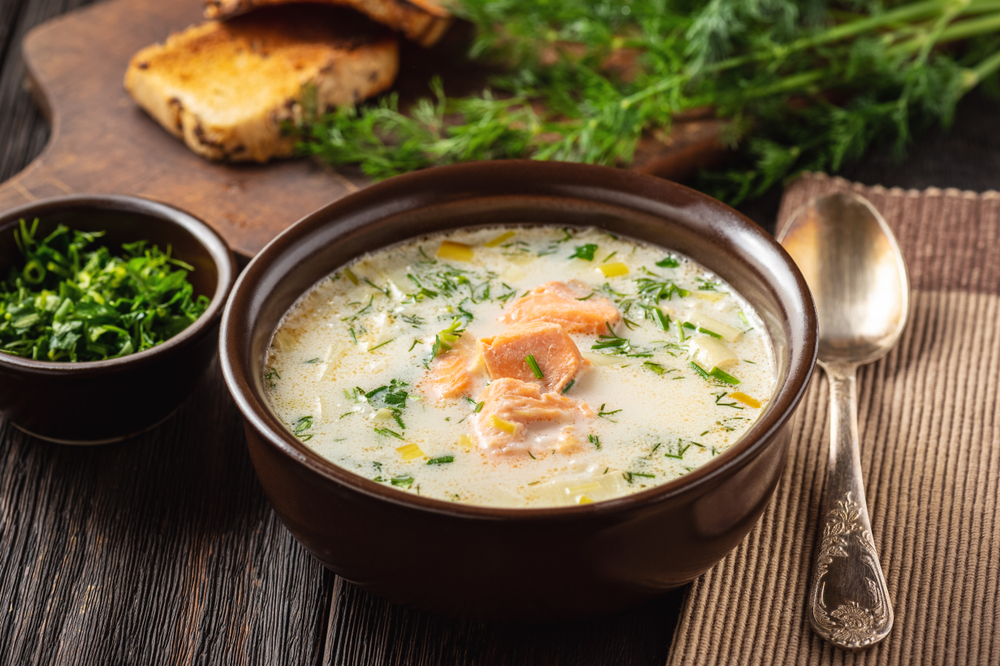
[322,572,686,666]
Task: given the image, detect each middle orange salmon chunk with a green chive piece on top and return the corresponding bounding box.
[480,321,589,391]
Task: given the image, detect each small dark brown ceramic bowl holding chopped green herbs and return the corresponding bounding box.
[0,195,236,444]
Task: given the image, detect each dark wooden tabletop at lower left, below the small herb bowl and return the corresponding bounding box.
[0,360,334,666]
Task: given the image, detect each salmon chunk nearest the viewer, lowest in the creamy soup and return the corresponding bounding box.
[472,377,594,454]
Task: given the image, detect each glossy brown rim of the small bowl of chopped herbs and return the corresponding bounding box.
[0,194,237,376]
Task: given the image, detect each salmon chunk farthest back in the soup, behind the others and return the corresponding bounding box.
[500,280,622,335]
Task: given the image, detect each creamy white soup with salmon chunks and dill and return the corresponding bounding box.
[265,227,775,507]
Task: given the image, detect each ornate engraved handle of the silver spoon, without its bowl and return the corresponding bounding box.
[807,363,893,650]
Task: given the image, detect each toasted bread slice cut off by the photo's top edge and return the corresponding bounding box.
[205,0,451,46]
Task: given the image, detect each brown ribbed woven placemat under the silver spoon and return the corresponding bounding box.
[668,174,1000,666]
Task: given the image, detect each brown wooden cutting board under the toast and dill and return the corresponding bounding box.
[0,0,721,256]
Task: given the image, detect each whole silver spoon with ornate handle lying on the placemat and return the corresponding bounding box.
[778,193,909,650]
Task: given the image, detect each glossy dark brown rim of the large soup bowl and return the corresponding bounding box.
[219,160,818,521]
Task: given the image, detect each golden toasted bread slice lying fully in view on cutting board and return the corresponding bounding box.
[125,5,399,162]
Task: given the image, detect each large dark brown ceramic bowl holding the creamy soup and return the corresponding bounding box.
[220,161,816,621]
